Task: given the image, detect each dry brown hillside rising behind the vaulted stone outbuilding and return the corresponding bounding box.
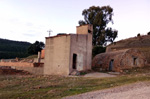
[106,35,150,63]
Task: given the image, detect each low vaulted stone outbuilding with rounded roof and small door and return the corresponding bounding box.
[92,49,146,72]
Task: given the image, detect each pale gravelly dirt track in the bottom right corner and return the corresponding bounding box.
[63,82,150,99]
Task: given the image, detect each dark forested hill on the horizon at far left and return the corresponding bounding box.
[0,38,31,59]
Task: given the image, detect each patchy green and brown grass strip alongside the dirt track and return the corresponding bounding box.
[0,67,150,99]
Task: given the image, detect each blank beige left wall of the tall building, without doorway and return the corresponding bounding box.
[44,35,70,75]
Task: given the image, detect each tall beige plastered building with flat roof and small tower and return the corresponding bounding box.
[44,25,93,75]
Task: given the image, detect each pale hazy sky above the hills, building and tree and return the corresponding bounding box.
[0,0,150,43]
